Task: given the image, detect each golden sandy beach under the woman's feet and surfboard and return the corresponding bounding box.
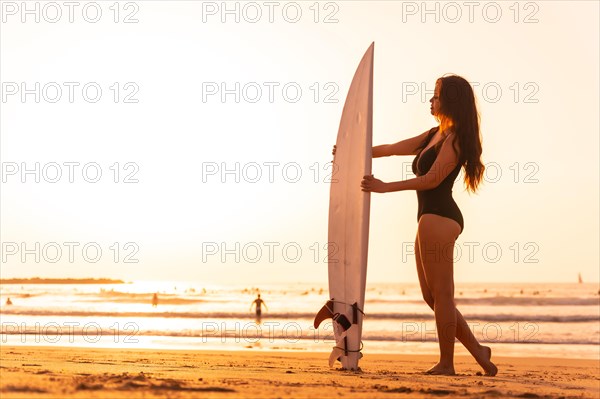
[0,346,600,398]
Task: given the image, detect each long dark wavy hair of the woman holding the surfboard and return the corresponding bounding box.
[436,75,485,193]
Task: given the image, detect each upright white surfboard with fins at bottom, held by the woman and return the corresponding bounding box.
[314,43,375,370]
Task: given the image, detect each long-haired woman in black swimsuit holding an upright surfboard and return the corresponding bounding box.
[361,75,498,376]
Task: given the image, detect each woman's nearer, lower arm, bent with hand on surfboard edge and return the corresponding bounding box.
[361,135,458,193]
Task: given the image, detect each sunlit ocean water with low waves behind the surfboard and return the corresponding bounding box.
[0,282,600,359]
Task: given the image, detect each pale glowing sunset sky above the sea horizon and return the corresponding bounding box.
[0,1,600,286]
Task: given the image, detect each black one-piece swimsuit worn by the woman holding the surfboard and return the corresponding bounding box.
[412,127,464,233]
